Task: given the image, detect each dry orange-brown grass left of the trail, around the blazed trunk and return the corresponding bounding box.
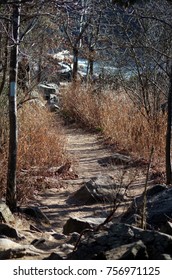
[0,99,68,203]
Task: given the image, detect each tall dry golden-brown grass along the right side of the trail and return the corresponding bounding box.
[63,85,166,166]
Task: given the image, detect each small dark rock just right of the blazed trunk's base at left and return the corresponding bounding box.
[20,206,51,225]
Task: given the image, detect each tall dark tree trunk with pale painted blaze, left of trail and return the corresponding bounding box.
[6,4,21,212]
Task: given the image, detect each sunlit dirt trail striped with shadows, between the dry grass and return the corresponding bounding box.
[38,123,147,233]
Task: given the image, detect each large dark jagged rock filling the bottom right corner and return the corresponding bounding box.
[67,223,172,260]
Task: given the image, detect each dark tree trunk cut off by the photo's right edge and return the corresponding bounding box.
[166,64,172,184]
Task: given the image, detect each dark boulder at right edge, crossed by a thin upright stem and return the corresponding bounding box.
[121,185,172,229]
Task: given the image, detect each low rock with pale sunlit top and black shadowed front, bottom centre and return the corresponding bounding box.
[63,217,108,235]
